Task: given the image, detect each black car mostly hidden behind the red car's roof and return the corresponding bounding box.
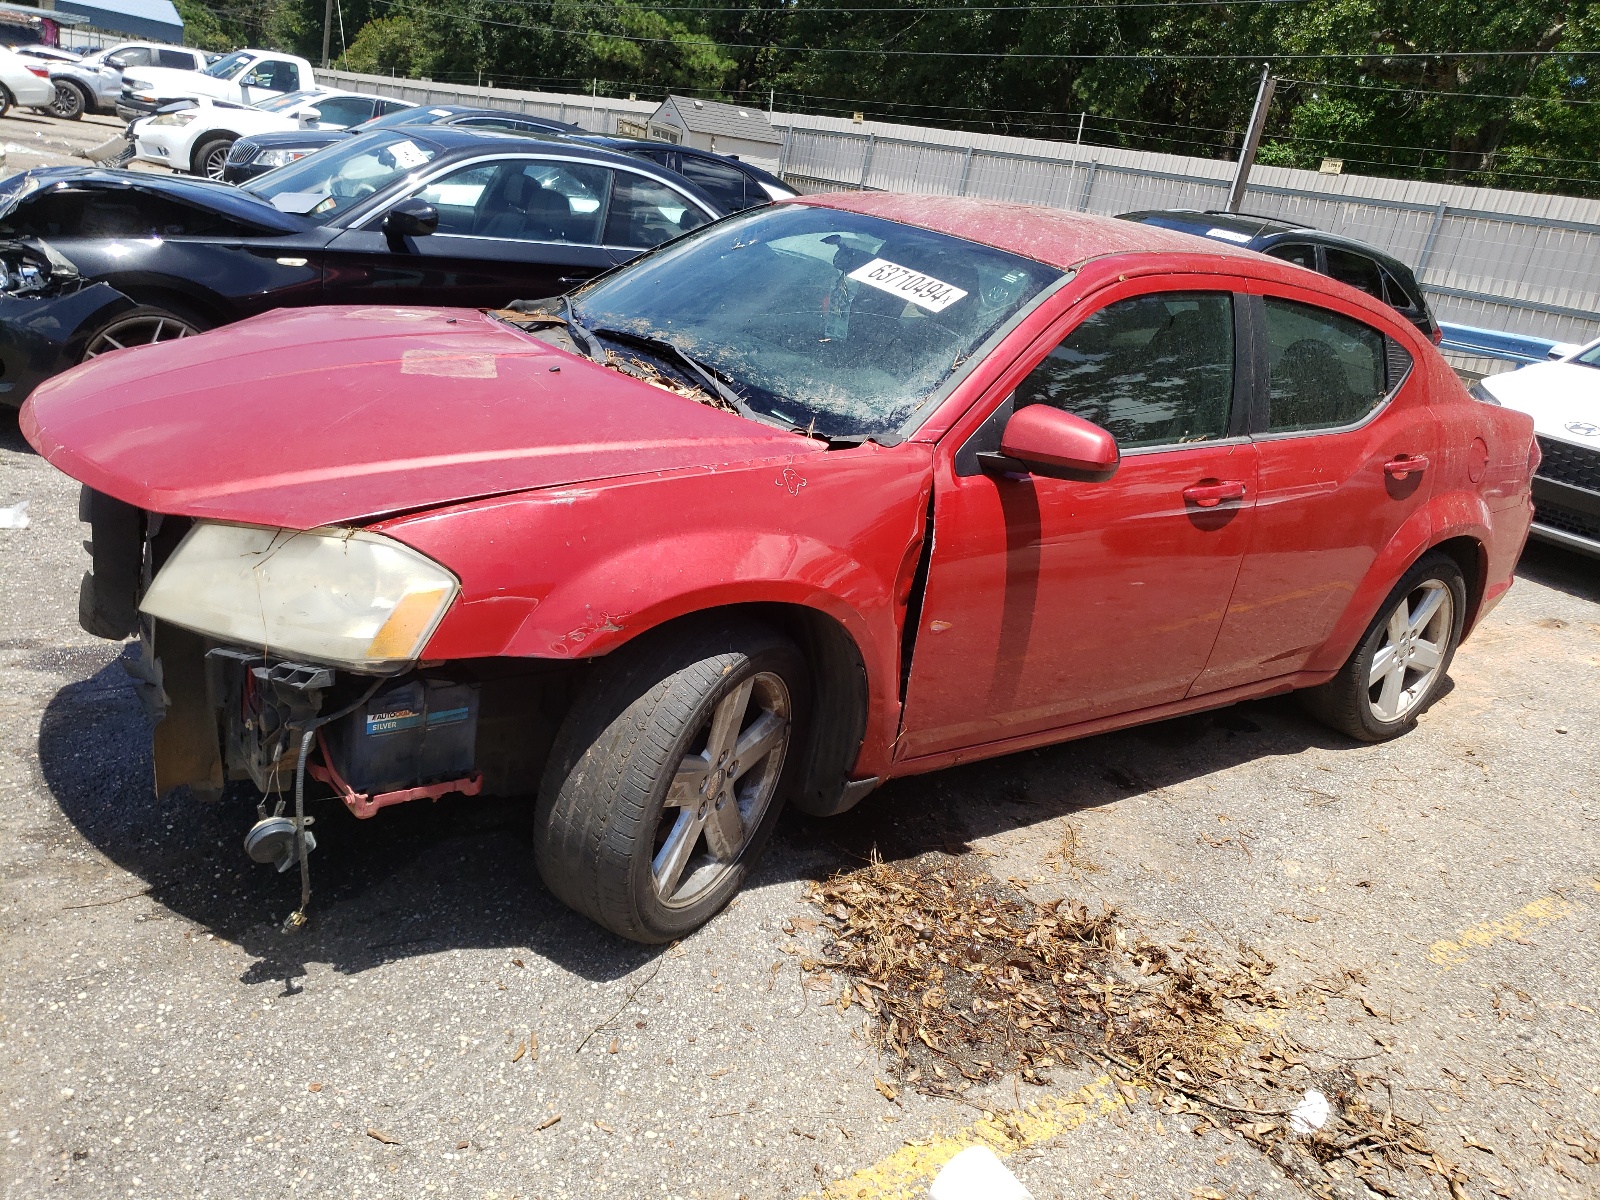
[1120,208,1443,346]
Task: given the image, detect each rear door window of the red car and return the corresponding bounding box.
[1266,299,1387,434]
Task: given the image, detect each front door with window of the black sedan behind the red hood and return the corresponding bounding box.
[323,157,613,309]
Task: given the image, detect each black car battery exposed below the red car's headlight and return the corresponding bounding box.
[328,675,480,795]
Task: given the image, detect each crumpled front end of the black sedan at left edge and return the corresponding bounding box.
[0,238,136,408]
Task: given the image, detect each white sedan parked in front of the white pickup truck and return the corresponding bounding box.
[133,88,403,179]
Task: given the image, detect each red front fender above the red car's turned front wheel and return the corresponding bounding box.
[376,442,931,764]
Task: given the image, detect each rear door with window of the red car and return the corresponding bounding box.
[1194,284,1440,694]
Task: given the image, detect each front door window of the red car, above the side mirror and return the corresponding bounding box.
[1016,291,1234,448]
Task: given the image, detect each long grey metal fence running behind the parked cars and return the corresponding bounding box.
[322,72,1600,361]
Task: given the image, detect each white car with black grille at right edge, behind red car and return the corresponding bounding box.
[1474,339,1600,558]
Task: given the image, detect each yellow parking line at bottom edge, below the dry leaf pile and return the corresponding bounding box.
[814,1075,1133,1200]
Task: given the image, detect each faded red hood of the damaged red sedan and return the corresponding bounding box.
[21,307,821,530]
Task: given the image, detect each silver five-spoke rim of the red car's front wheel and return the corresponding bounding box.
[650,670,792,907]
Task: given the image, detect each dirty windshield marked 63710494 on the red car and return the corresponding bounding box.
[573,205,1061,438]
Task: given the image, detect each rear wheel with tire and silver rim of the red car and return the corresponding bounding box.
[1301,554,1467,742]
